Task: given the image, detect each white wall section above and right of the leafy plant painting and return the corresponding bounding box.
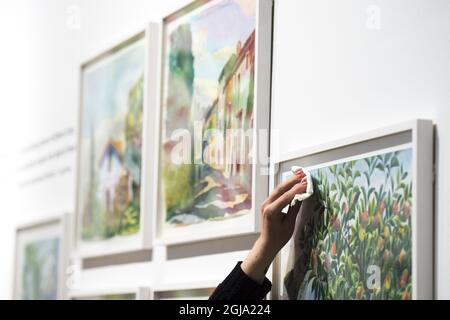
[272,0,450,299]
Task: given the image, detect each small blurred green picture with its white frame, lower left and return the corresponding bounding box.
[13,214,70,300]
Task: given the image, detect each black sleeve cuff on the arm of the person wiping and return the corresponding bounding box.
[209,262,272,301]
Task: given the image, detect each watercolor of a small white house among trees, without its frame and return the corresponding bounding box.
[78,36,145,242]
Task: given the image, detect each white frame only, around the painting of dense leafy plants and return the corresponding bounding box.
[271,120,434,300]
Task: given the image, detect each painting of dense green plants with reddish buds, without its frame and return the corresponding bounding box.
[281,147,413,300]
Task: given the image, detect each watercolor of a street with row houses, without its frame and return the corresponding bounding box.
[160,0,257,229]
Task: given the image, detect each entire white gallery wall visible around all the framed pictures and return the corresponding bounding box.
[0,0,450,299]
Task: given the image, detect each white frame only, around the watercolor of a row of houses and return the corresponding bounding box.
[154,0,273,246]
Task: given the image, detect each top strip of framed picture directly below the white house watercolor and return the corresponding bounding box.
[69,287,152,300]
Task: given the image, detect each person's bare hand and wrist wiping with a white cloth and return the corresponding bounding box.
[241,170,307,283]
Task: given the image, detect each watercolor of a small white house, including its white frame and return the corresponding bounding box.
[75,24,159,258]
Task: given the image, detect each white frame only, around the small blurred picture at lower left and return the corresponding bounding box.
[13,213,71,300]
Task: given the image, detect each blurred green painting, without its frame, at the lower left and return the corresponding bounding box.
[18,238,59,300]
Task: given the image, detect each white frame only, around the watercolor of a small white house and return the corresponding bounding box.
[73,22,159,259]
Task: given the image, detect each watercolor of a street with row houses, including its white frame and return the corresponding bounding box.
[155,0,273,245]
